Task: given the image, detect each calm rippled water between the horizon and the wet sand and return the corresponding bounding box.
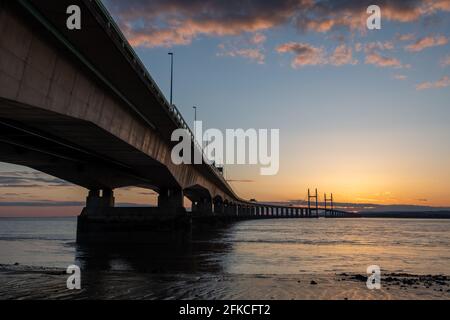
[0,218,450,275]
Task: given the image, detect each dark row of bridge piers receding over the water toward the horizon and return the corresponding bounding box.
[77,189,355,242]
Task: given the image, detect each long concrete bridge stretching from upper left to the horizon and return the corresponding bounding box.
[0,0,354,240]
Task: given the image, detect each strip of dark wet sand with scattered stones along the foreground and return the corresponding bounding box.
[0,265,450,300]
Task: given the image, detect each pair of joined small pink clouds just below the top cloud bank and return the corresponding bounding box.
[276,42,357,68]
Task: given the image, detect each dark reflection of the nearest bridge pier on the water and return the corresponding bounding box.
[75,225,236,273]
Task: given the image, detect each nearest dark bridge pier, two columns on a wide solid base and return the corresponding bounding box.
[77,189,191,243]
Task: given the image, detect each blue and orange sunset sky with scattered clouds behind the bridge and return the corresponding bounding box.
[0,0,450,215]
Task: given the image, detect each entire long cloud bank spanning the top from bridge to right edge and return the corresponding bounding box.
[105,0,450,47]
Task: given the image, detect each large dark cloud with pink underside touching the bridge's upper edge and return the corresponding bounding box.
[106,0,303,47]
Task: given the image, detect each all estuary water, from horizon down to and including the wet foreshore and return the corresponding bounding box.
[0,218,450,300]
